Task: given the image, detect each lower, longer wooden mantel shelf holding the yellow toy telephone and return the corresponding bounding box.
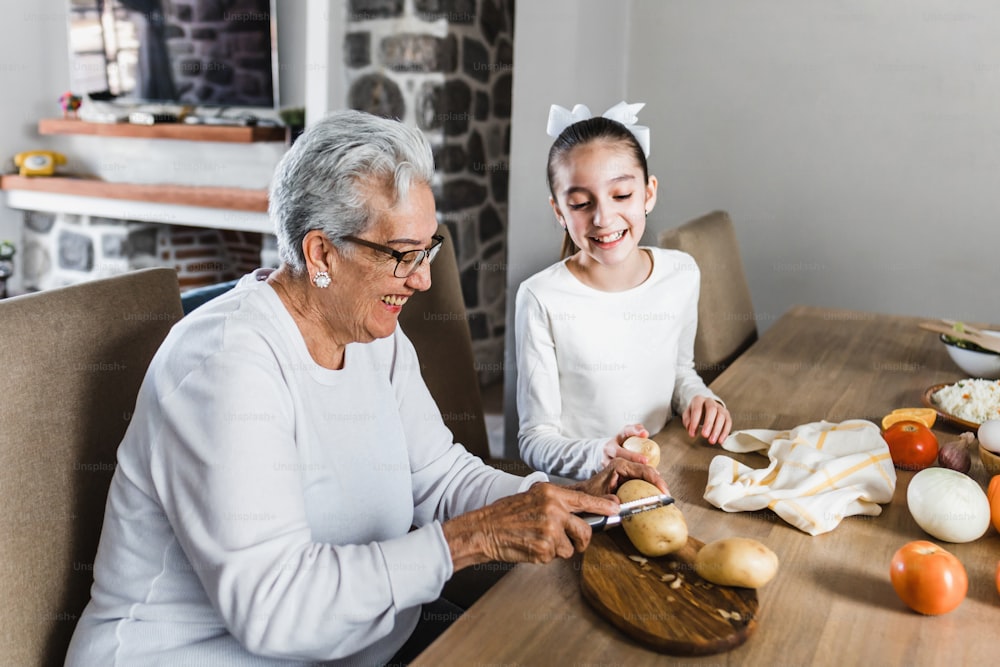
[0,174,267,213]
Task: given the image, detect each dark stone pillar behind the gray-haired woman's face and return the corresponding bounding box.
[344,0,514,384]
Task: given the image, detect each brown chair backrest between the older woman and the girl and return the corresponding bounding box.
[399,225,490,461]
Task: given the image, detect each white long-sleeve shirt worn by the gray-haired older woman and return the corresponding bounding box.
[67,276,544,667]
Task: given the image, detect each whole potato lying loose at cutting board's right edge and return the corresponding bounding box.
[694,537,778,588]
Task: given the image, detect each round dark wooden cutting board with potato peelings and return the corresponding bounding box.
[580,529,758,655]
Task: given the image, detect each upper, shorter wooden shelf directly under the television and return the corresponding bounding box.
[38,118,285,144]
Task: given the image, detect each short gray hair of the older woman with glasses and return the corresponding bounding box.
[268,110,434,274]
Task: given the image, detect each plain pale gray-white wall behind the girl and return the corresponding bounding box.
[505,0,1000,455]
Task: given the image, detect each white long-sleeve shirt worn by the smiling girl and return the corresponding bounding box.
[515,248,718,479]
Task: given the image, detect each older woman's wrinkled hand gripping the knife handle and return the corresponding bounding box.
[442,482,616,570]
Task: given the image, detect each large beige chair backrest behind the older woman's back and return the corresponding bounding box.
[0,268,181,667]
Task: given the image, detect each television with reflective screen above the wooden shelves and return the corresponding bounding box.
[69,0,278,109]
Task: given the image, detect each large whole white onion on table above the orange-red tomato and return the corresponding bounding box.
[906,468,990,542]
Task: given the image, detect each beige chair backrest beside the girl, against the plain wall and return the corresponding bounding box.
[659,211,757,382]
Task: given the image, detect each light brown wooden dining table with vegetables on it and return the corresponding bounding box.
[414,307,1000,667]
